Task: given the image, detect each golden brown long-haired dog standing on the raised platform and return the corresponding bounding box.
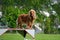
[17,9,36,29]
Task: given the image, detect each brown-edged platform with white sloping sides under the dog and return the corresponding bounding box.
[0,28,35,38]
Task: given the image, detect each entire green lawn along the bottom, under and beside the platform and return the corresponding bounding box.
[0,33,60,40]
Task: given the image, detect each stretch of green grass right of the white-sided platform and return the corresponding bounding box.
[36,34,60,40]
